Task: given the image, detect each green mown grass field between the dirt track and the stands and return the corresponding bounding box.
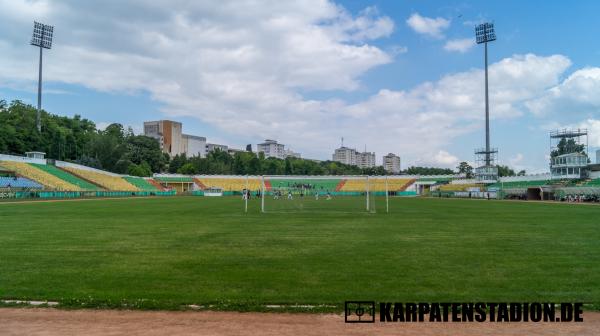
[0,197,600,310]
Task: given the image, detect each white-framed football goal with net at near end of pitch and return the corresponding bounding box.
[261,176,387,213]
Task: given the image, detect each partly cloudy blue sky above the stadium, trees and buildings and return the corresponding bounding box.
[0,0,600,172]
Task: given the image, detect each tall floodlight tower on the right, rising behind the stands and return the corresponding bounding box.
[475,22,498,182]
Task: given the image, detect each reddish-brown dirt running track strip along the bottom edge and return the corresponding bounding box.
[0,308,600,336]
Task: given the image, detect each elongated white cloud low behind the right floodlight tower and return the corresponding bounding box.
[335,54,570,164]
